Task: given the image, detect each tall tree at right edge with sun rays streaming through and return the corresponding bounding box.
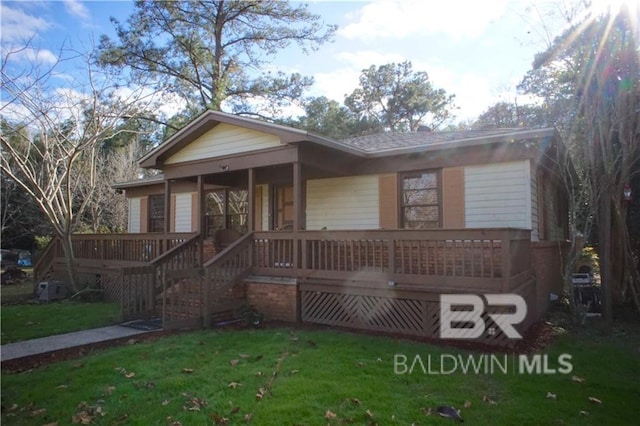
[529,7,640,320]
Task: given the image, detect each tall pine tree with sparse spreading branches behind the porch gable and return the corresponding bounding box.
[100,0,336,113]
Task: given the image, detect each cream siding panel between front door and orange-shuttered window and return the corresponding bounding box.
[306,175,380,230]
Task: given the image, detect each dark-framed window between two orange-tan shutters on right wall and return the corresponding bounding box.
[401,171,440,229]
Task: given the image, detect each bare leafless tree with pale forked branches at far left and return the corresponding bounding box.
[0,45,153,292]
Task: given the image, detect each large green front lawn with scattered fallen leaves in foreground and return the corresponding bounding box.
[1,328,640,425]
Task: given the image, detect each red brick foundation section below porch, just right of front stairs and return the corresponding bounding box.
[245,277,299,322]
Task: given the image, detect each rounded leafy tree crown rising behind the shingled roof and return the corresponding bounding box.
[345,61,454,132]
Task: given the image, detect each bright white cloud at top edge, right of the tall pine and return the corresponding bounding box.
[338,0,507,40]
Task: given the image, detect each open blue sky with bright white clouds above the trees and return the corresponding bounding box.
[0,0,635,122]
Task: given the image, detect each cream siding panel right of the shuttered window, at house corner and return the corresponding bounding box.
[464,161,531,229]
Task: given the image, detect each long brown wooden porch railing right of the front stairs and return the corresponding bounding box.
[253,228,531,291]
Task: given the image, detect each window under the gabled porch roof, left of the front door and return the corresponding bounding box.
[206,188,249,237]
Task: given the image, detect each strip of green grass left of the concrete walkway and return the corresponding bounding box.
[0,301,120,344]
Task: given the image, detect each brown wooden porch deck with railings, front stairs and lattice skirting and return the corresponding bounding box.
[35,228,535,343]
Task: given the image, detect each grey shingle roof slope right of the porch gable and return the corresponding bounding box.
[340,128,550,154]
